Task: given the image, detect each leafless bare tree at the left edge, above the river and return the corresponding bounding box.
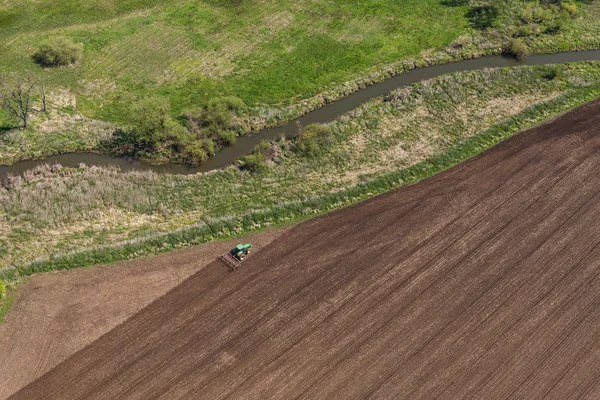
[0,73,36,128]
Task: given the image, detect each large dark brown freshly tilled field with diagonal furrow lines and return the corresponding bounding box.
[8,97,600,400]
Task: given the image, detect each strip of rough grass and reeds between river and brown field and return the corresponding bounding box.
[0,62,600,318]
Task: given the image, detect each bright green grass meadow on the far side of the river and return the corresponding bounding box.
[0,0,468,122]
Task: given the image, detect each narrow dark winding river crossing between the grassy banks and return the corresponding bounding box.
[0,50,600,180]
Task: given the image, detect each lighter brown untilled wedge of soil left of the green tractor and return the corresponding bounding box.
[0,228,290,399]
